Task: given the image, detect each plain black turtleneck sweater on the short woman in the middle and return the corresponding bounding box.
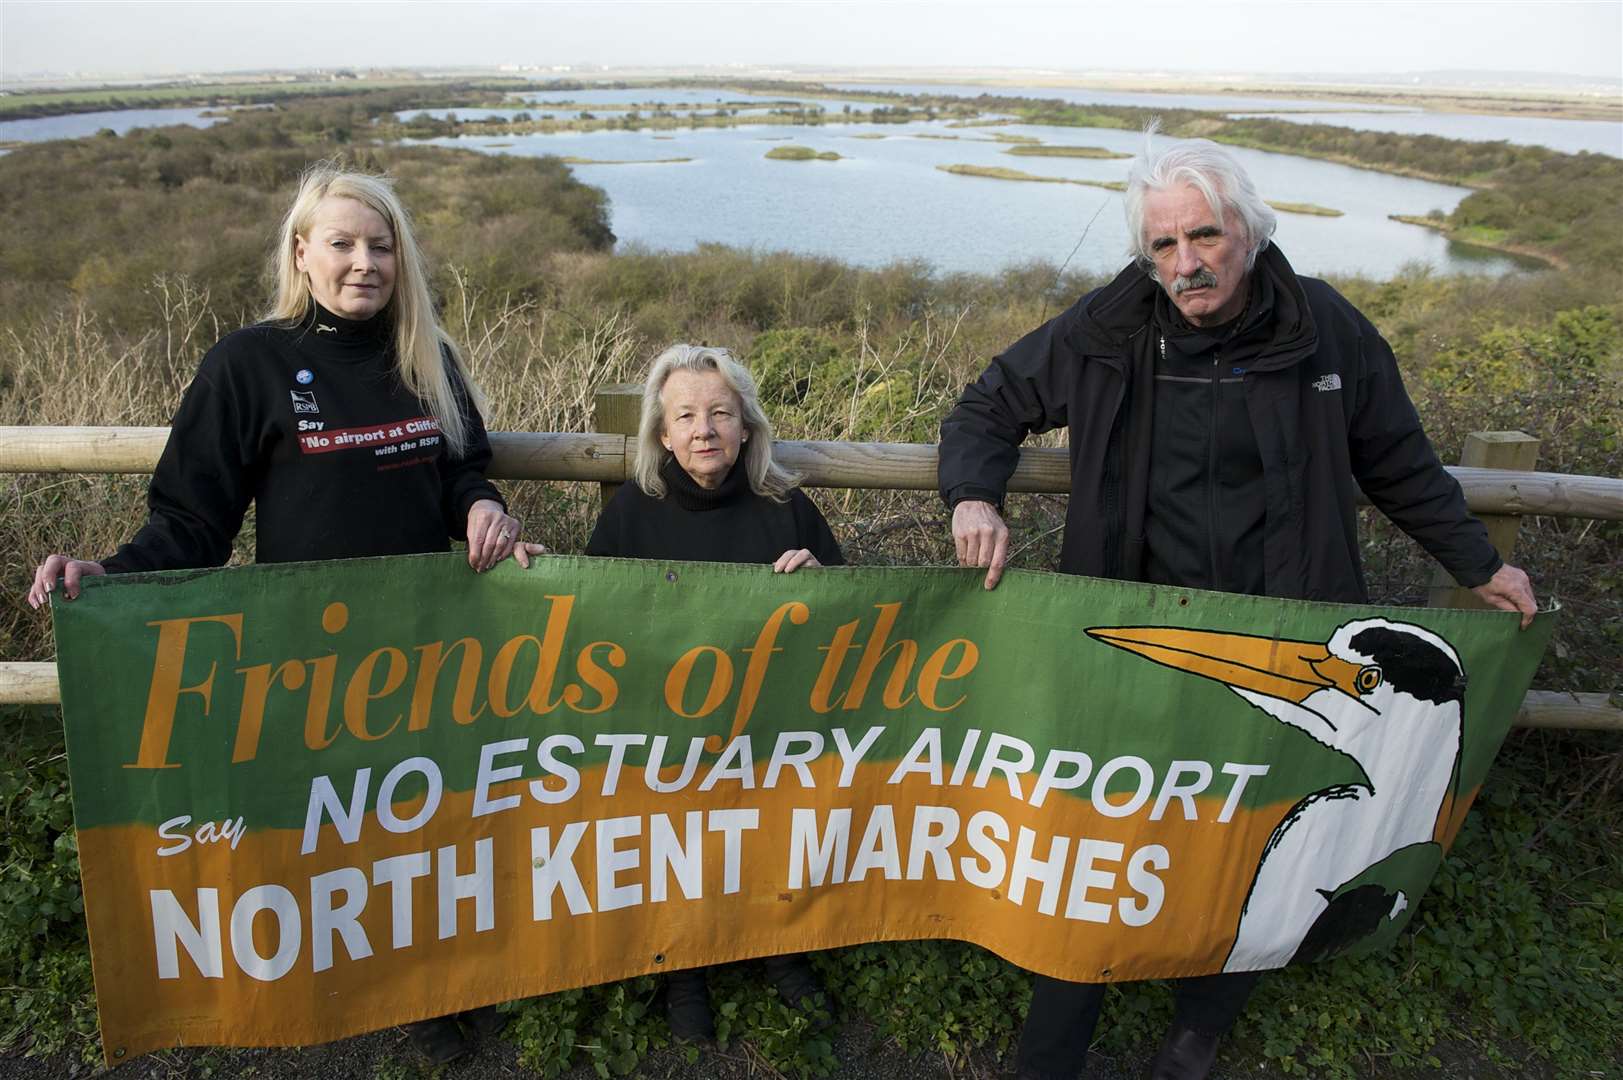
[586,456,846,567]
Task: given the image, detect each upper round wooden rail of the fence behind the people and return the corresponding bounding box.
[0,427,1623,521]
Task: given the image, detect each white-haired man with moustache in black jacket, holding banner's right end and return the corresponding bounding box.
[940,128,1535,1080]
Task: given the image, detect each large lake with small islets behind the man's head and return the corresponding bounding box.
[408,119,1518,278]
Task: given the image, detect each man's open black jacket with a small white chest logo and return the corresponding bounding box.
[940,245,1503,603]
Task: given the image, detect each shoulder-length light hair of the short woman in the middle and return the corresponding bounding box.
[633,344,800,502]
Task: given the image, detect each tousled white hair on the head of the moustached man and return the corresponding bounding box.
[1121,120,1279,274]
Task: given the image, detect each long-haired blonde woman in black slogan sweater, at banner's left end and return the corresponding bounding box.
[28,162,519,1062]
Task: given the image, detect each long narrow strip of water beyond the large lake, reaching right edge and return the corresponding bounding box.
[829,83,1623,158]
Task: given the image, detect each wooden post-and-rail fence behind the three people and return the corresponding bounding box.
[0,422,1623,731]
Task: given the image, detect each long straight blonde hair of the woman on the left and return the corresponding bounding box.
[265,161,485,455]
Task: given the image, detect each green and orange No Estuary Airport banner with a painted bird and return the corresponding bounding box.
[55,555,1552,1059]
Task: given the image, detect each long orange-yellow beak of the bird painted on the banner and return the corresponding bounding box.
[1087,627,1360,705]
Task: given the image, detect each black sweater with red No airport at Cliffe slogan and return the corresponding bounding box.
[102,307,502,573]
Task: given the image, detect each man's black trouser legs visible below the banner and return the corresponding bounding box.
[1014,971,1263,1080]
